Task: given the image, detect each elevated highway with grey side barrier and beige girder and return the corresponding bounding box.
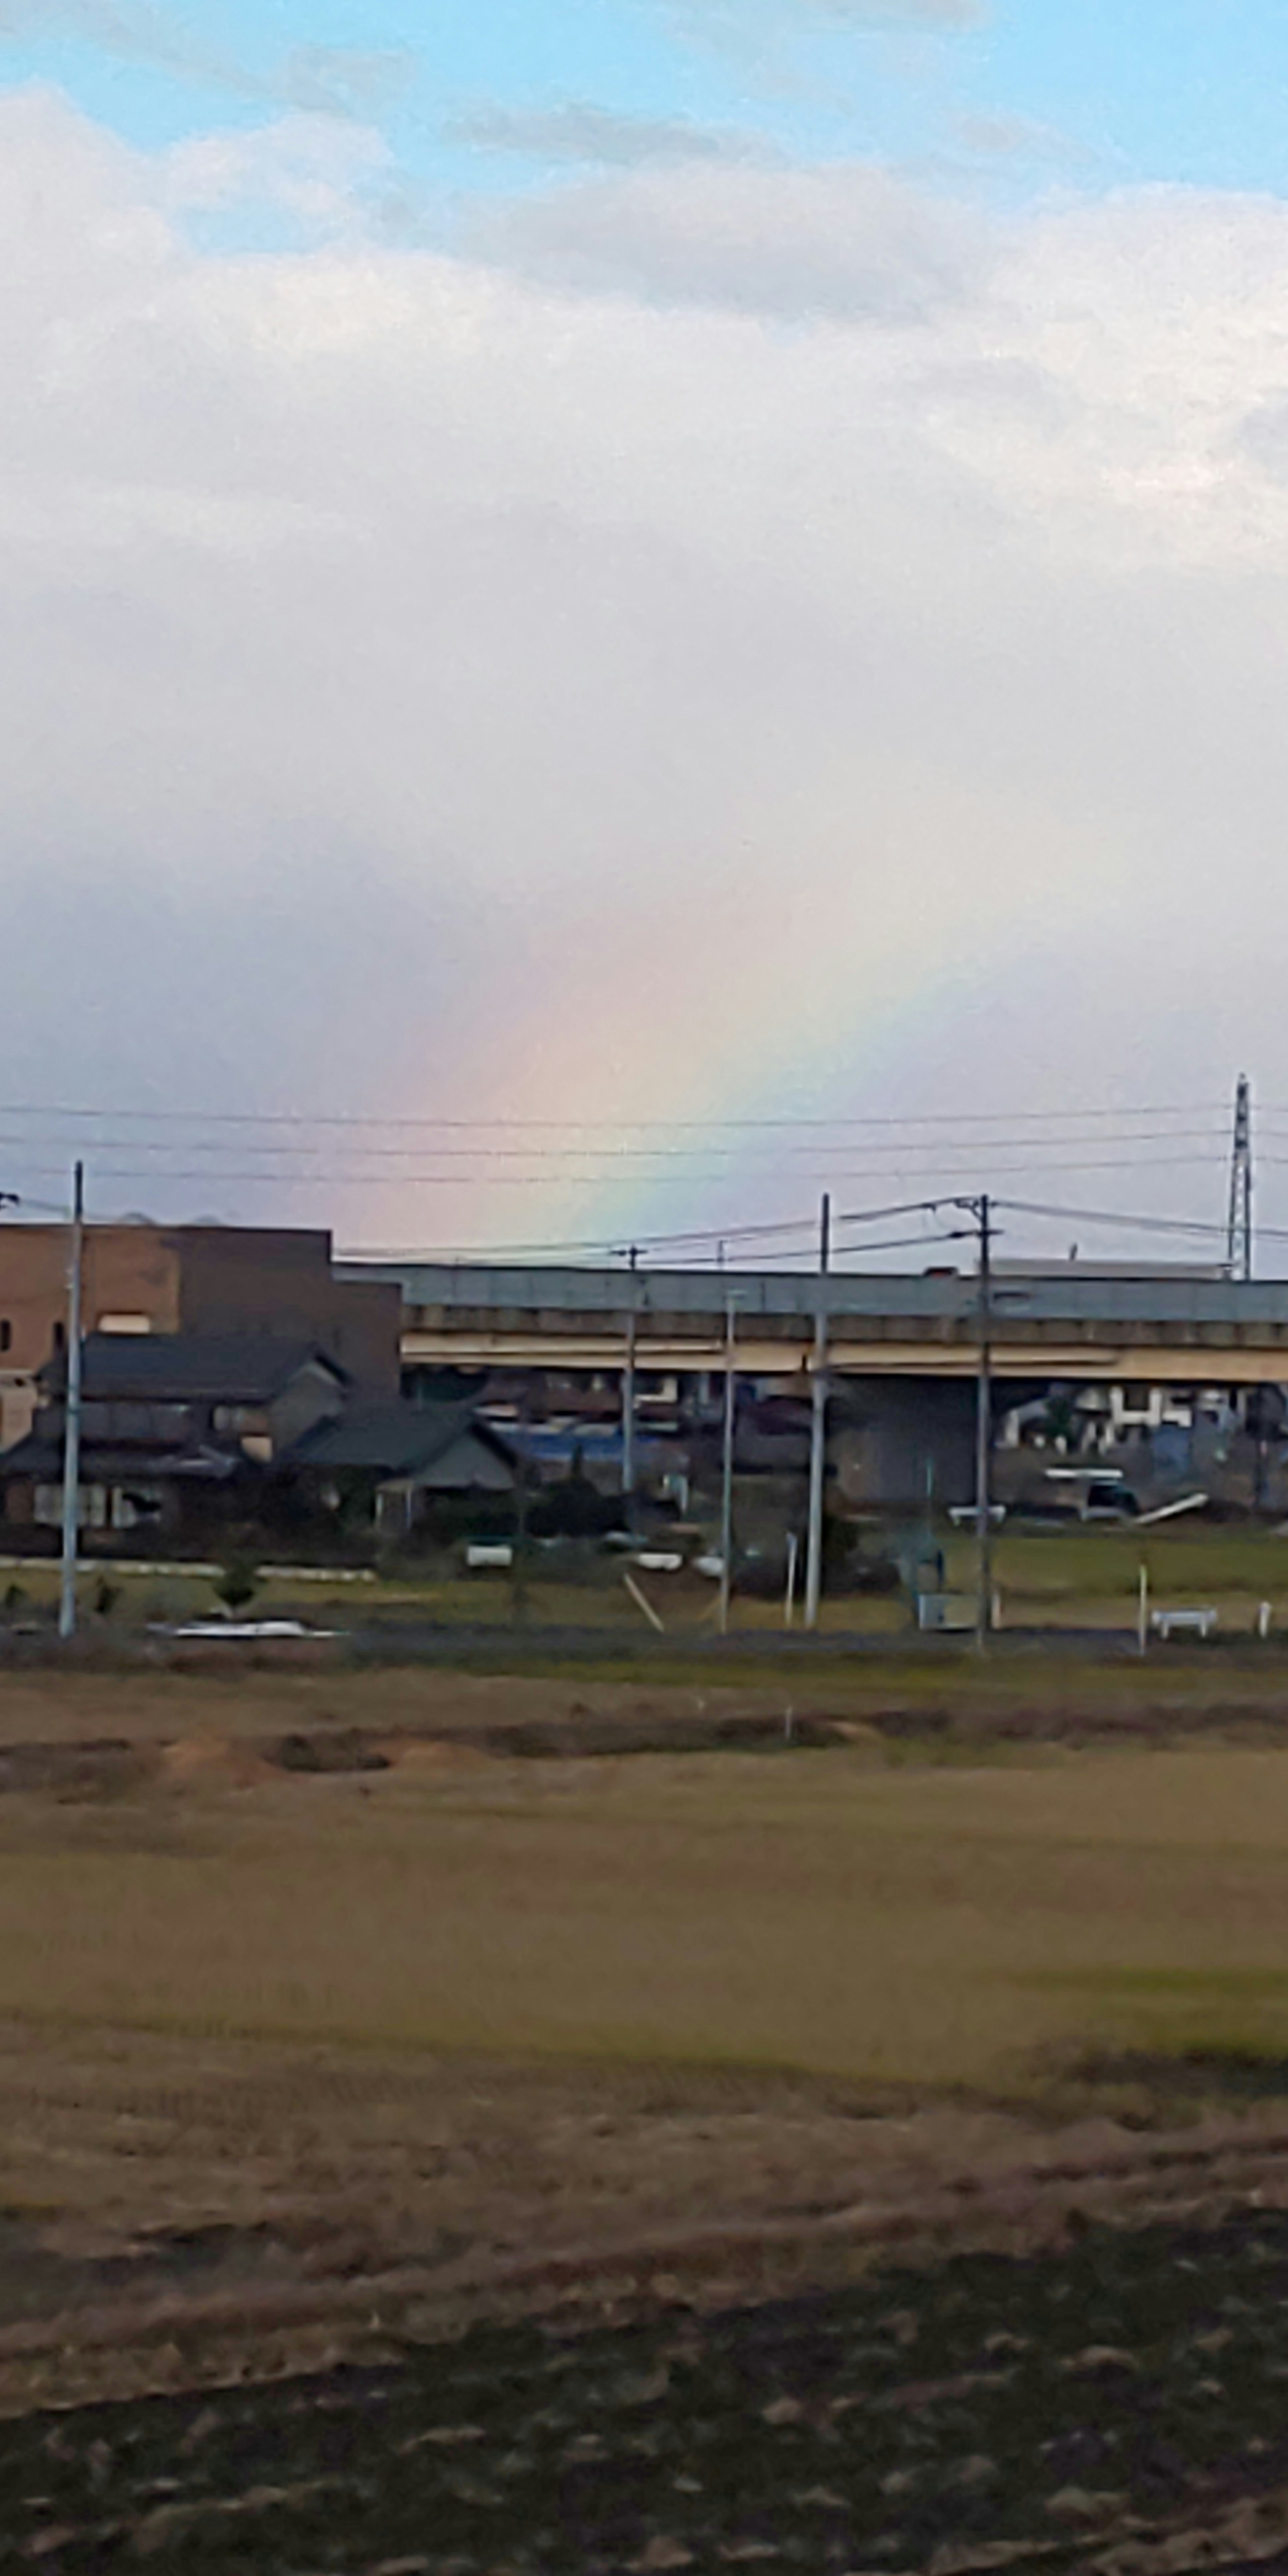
[340,1262,1288,1389]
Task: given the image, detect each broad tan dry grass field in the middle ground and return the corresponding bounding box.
[0,1749,1288,2092]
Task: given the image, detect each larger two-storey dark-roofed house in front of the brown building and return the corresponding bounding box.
[0,1332,350,1541]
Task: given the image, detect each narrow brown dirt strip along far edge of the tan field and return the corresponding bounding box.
[0,1646,1288,1752]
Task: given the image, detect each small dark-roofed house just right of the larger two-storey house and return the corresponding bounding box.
[283,1404,515,1535]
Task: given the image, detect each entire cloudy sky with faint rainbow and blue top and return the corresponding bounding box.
[0,0,1288,1270]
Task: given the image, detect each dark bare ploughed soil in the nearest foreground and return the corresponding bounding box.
[12,2213,1288,2576]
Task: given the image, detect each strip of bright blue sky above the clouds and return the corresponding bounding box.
[0,0,1288,219]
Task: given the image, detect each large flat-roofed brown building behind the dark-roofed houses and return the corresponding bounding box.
[0,1224,402,1448]
